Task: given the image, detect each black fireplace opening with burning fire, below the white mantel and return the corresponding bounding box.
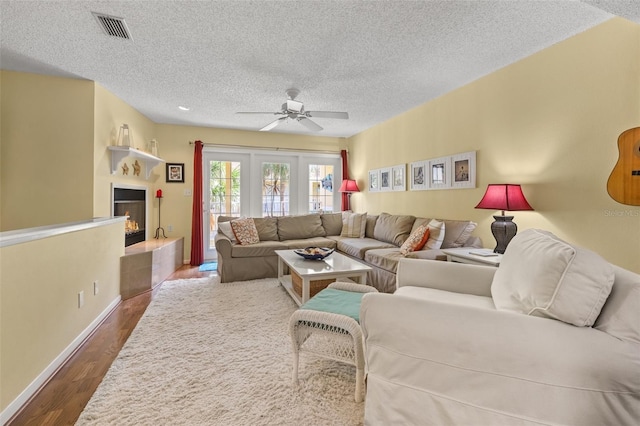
[113,186,147,247]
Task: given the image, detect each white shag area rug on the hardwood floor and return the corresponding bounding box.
[76,277,364,425]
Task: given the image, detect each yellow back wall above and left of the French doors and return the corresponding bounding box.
[152,121,346,259]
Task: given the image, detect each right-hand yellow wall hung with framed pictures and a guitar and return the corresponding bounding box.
[349,18,640,272]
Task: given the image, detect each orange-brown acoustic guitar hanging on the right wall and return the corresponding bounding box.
[607,127,640,206]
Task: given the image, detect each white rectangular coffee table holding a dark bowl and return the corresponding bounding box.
[276,250,371,306]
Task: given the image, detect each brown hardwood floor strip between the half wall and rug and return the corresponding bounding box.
[7,265,217,426]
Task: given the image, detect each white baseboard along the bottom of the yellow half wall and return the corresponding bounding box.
[0,295,122,425]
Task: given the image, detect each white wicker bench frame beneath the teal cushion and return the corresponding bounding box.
[289,281,377,402]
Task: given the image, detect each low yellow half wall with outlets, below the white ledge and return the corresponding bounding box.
[0,222,124,411]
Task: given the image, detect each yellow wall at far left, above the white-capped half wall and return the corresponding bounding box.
[0,71,94,231]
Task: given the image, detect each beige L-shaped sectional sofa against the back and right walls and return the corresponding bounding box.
[215,213,482,293]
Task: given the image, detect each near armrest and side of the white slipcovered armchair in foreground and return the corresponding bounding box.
[360,293,640,424]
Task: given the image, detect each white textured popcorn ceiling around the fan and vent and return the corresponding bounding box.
[0,0,640,137]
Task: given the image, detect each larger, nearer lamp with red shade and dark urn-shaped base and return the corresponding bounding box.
[476,184,533,254]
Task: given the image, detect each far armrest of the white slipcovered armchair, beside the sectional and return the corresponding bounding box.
[396,259,498,297]
